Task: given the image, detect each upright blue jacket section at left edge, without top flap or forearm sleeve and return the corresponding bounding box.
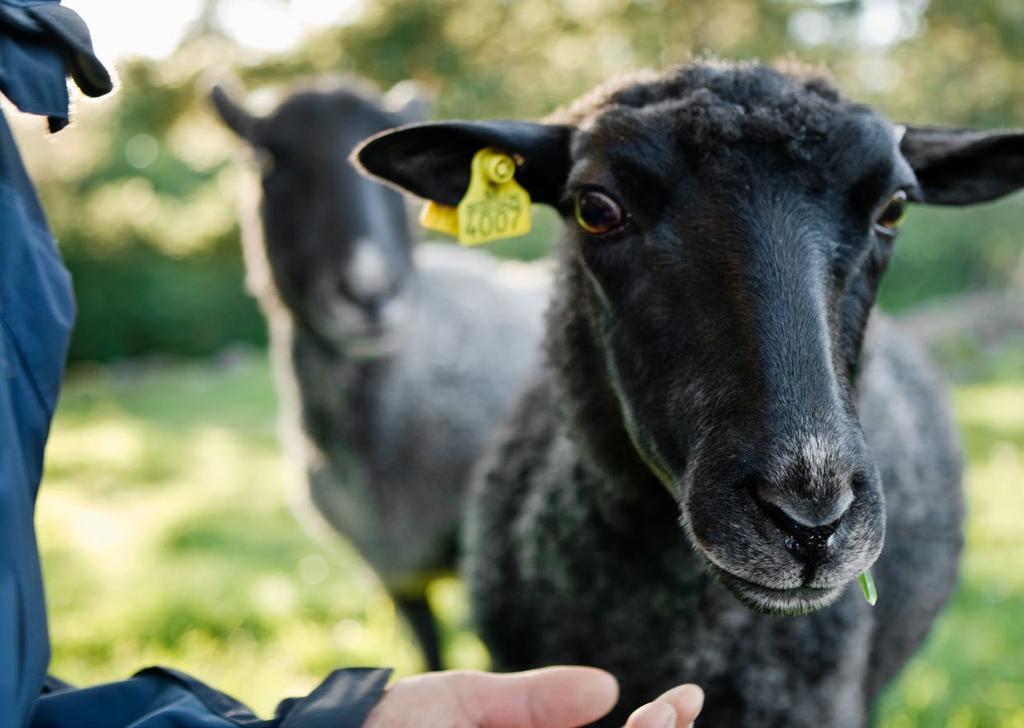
[0,82,75,726]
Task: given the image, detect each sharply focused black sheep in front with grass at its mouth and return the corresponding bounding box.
[357,62,1024,728]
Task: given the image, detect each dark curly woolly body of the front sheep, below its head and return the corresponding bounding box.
[466,308,963,728]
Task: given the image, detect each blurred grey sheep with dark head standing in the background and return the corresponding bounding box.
[213,79,549,669]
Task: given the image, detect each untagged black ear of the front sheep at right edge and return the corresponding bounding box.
[900,126,1024,205]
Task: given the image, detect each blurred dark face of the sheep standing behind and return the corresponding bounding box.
[215,82,428,348]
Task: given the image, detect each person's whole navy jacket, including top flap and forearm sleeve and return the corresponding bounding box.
[0,0,389,728]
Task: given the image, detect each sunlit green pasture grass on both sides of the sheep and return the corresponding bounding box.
[38,355,1024,728]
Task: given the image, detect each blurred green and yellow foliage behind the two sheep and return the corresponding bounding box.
[14,0,1024,360]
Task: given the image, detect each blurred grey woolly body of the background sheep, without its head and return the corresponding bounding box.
[272,244,548,598]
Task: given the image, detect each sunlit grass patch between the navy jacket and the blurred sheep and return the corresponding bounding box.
[38,359,432,713]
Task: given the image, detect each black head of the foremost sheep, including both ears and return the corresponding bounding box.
[357,66,1024,613]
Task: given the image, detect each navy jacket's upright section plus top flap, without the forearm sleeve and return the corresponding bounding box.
[0,0,110,726]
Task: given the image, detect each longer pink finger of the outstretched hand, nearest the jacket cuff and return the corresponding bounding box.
[453,668,618,728]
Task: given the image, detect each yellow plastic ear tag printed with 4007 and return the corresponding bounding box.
[420,147,530,245]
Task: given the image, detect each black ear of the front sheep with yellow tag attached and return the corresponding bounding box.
[352,121,572,206]
